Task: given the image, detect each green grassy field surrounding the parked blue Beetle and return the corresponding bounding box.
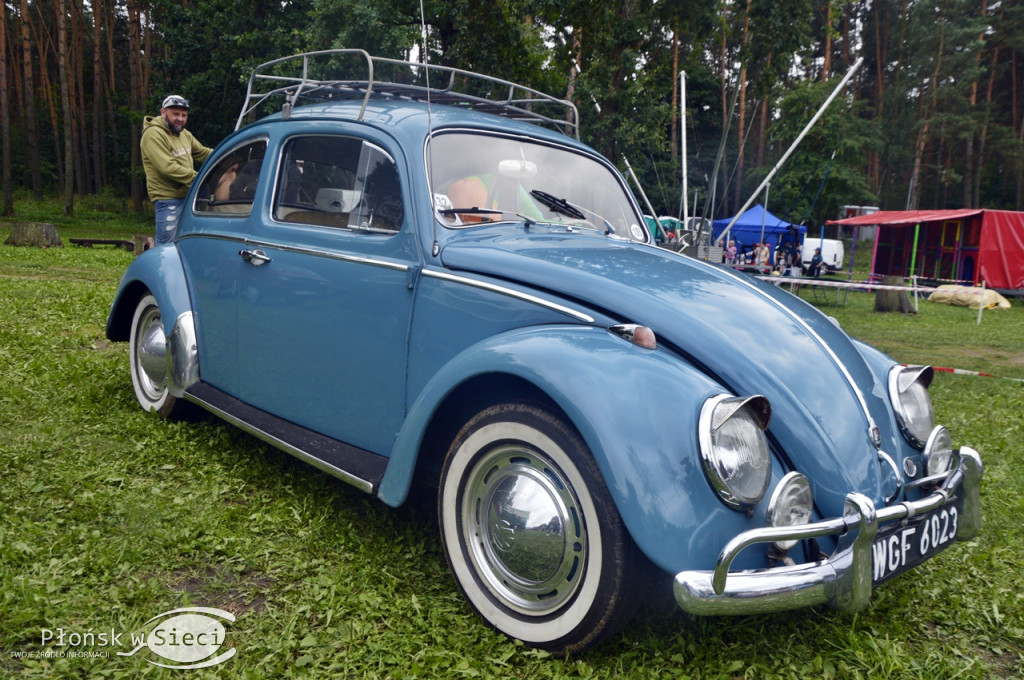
[0,206,1024,680]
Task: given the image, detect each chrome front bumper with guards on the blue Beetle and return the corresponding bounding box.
[673,447,983,615]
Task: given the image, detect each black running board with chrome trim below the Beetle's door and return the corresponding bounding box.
[184,382,388,495]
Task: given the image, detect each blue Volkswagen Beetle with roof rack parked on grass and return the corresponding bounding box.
[106,50,982,653]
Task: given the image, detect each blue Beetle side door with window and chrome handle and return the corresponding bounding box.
[237,134,419,455]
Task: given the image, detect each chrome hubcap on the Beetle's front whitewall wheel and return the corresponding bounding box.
[463,445,587,615]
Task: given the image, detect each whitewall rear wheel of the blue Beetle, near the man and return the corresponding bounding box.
[129,294,191,420]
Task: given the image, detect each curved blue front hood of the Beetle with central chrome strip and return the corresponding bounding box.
[441,233,900,516]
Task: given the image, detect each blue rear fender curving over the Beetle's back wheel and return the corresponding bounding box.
[106,244,191,342]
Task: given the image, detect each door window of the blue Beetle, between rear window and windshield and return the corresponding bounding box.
[273,136,404,233]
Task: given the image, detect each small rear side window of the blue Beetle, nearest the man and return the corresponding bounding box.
[196,139,266,216]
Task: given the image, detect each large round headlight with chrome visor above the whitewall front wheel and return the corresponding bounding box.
[699,394,771,510]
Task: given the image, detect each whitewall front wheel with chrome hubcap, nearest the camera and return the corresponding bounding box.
[438,401,643,654]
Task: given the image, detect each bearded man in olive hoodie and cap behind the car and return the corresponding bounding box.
[140,94,213,244]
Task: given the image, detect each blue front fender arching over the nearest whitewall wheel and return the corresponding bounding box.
[379,326,777,572]
